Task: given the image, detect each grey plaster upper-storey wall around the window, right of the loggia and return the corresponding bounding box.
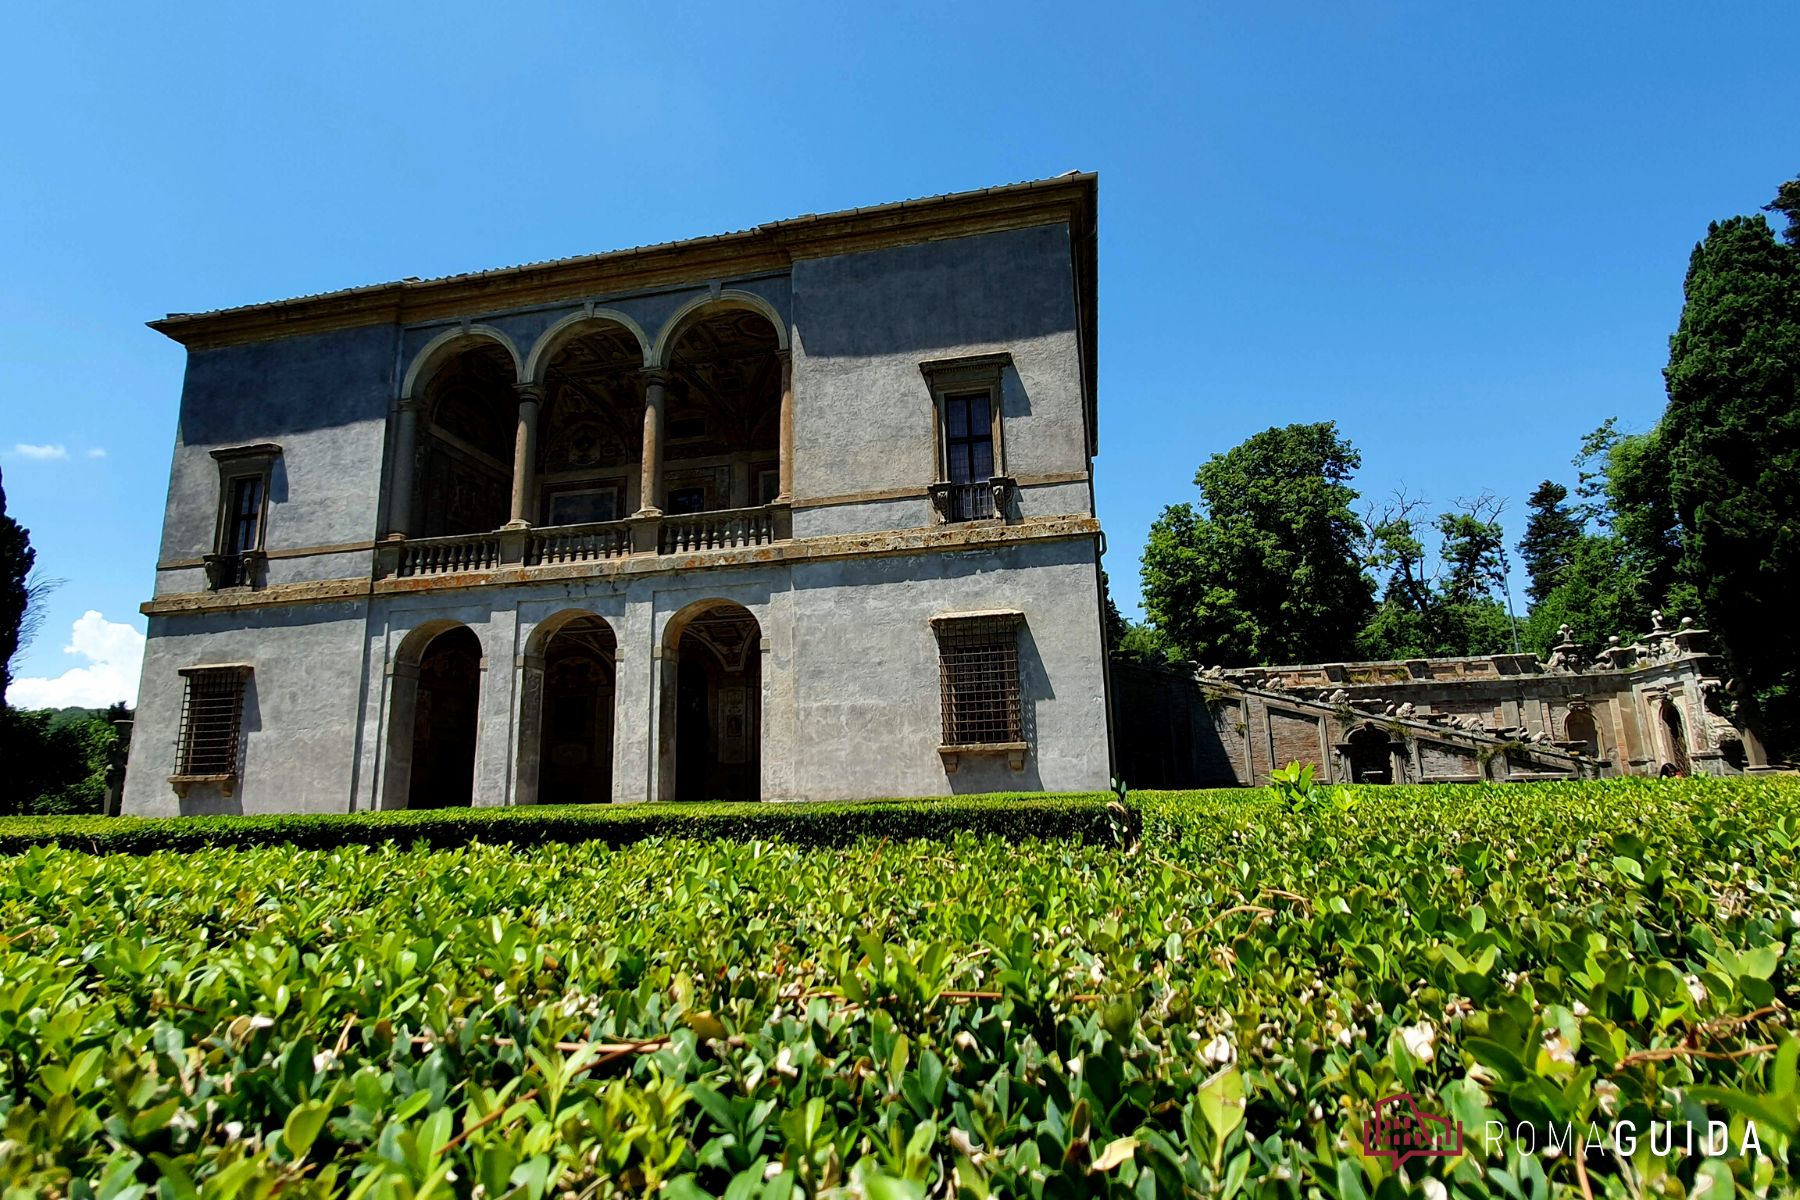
[794,225,1091,533]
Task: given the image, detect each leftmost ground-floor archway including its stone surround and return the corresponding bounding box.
[382,619,486,808]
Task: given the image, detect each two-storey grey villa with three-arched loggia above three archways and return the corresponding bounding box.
[124,175,1111,813]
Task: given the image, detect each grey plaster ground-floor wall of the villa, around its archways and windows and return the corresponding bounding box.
[124,538,1109,815]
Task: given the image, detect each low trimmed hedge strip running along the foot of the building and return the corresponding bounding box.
[0,793,1112,855]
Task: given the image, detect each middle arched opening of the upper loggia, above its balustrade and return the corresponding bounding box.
[527,320,644,525]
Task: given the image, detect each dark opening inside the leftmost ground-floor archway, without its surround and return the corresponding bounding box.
[405,624,481,808]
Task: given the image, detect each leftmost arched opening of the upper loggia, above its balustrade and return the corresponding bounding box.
[412,342,518,538]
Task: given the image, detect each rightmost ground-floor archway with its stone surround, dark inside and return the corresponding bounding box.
[659,601,763,801]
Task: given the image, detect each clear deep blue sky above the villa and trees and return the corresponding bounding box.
[0,0,1800,705]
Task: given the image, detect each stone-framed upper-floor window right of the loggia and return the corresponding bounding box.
[920,354,1012,522]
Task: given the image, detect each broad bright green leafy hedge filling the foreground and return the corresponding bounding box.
[0,781,1800,1200]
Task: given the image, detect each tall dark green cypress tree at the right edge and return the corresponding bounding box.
[1656,210,1800,745]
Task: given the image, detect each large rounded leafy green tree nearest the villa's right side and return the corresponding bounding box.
[1143,421,1373,666]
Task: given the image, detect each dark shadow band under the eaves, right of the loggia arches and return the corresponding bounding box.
[796,225,1075,358]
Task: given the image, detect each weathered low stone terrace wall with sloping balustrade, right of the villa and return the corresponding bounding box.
[1112,613,1768,788]
